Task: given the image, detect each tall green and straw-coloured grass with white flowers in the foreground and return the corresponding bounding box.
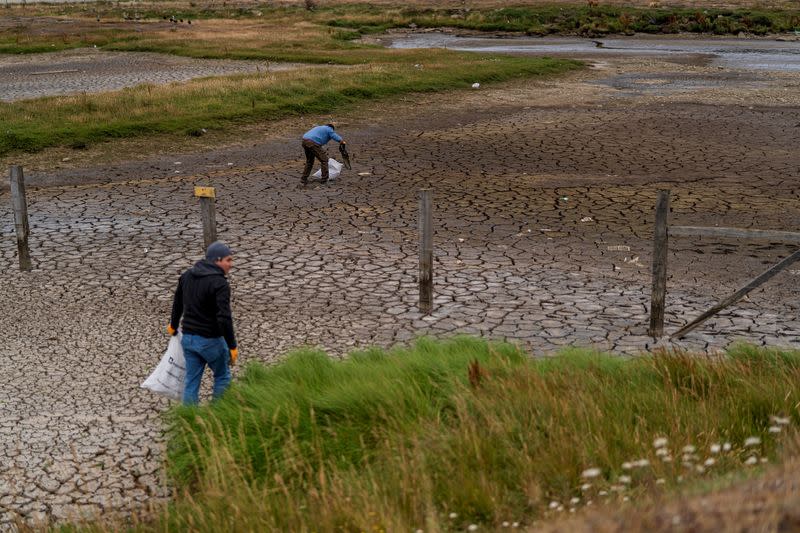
[90,338,800,531]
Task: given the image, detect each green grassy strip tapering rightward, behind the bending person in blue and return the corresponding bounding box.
[0,51,580,155]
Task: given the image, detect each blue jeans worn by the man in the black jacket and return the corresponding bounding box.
[181,333,231,404]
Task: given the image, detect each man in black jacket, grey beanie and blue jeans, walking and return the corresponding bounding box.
[167,241,239,404]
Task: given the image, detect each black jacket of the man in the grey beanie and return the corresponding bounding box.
[169,260,236,348]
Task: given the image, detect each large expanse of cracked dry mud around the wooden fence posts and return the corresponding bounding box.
[0,46,800,528]
